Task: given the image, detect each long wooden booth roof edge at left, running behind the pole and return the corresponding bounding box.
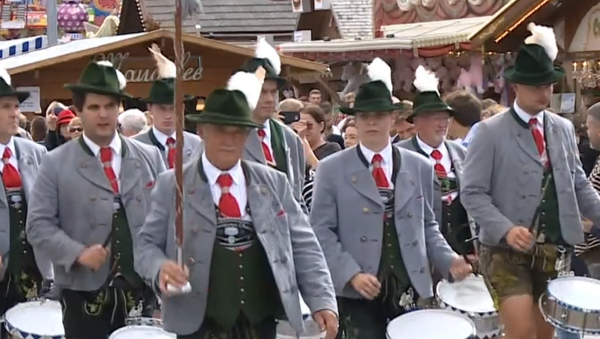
[0,30,328,79]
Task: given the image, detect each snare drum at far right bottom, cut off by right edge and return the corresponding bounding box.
[539,277,600,335]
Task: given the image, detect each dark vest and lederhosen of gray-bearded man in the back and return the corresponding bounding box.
[411,137,475,254]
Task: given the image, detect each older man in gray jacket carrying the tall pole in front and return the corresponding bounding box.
[135,67,337,339]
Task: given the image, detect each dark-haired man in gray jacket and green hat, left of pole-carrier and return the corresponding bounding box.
[26,61,165,339]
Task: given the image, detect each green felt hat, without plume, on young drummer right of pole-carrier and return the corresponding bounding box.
[340,80,403,115]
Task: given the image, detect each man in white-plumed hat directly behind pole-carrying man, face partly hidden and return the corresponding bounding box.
[242,39,306,206]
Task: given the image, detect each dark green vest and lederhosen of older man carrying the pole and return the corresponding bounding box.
[178,160,285,339]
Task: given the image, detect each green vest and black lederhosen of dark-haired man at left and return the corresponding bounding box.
[61,138,156,339]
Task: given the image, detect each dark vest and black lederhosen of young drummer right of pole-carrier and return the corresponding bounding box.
[338,147,418,339]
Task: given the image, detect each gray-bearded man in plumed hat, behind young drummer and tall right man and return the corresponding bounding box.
[397,66,475,254]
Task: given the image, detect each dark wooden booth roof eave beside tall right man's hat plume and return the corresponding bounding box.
[468,0,569,52]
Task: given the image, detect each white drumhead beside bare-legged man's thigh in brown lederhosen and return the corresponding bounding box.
[437,275,496,313]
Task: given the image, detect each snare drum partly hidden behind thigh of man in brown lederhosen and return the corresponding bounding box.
[436,275,501,339]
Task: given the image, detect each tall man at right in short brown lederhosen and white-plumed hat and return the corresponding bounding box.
[460,23,600,339]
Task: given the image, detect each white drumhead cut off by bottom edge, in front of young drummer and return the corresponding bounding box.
[387,310,476,339]
